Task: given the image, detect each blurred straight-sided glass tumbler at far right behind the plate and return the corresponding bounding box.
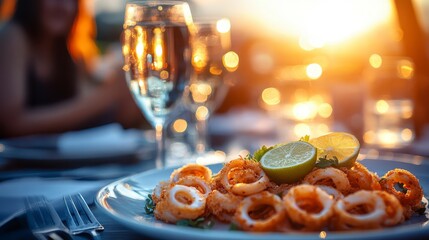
[363,55,415,148]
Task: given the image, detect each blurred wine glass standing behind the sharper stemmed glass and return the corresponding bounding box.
[184,18,238,156]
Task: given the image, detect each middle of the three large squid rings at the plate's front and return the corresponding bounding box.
[283,184,335,230]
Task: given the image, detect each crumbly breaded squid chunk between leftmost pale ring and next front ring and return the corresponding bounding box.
[206,190,243,223]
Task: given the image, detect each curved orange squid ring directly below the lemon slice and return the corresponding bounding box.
[303,167,350,194]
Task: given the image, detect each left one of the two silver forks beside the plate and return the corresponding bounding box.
[25,196,72,240]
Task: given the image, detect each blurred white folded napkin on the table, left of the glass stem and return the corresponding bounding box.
[58,124,143,155]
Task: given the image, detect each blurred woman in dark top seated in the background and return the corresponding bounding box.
[0,0,142,138]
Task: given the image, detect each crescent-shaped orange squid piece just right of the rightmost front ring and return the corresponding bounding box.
[374,190,404,226]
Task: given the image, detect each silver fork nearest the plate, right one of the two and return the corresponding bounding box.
[64,193,104,239]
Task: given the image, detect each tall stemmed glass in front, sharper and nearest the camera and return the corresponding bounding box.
[122,1,192,168]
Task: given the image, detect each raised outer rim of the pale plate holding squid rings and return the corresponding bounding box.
[95,158,429,239]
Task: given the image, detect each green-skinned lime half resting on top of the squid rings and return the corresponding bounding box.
[260,141,317,184]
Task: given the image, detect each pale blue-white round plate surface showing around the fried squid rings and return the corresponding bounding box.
[96,159,429,240]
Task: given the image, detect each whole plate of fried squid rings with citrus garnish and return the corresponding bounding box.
[96,134,429,239]
